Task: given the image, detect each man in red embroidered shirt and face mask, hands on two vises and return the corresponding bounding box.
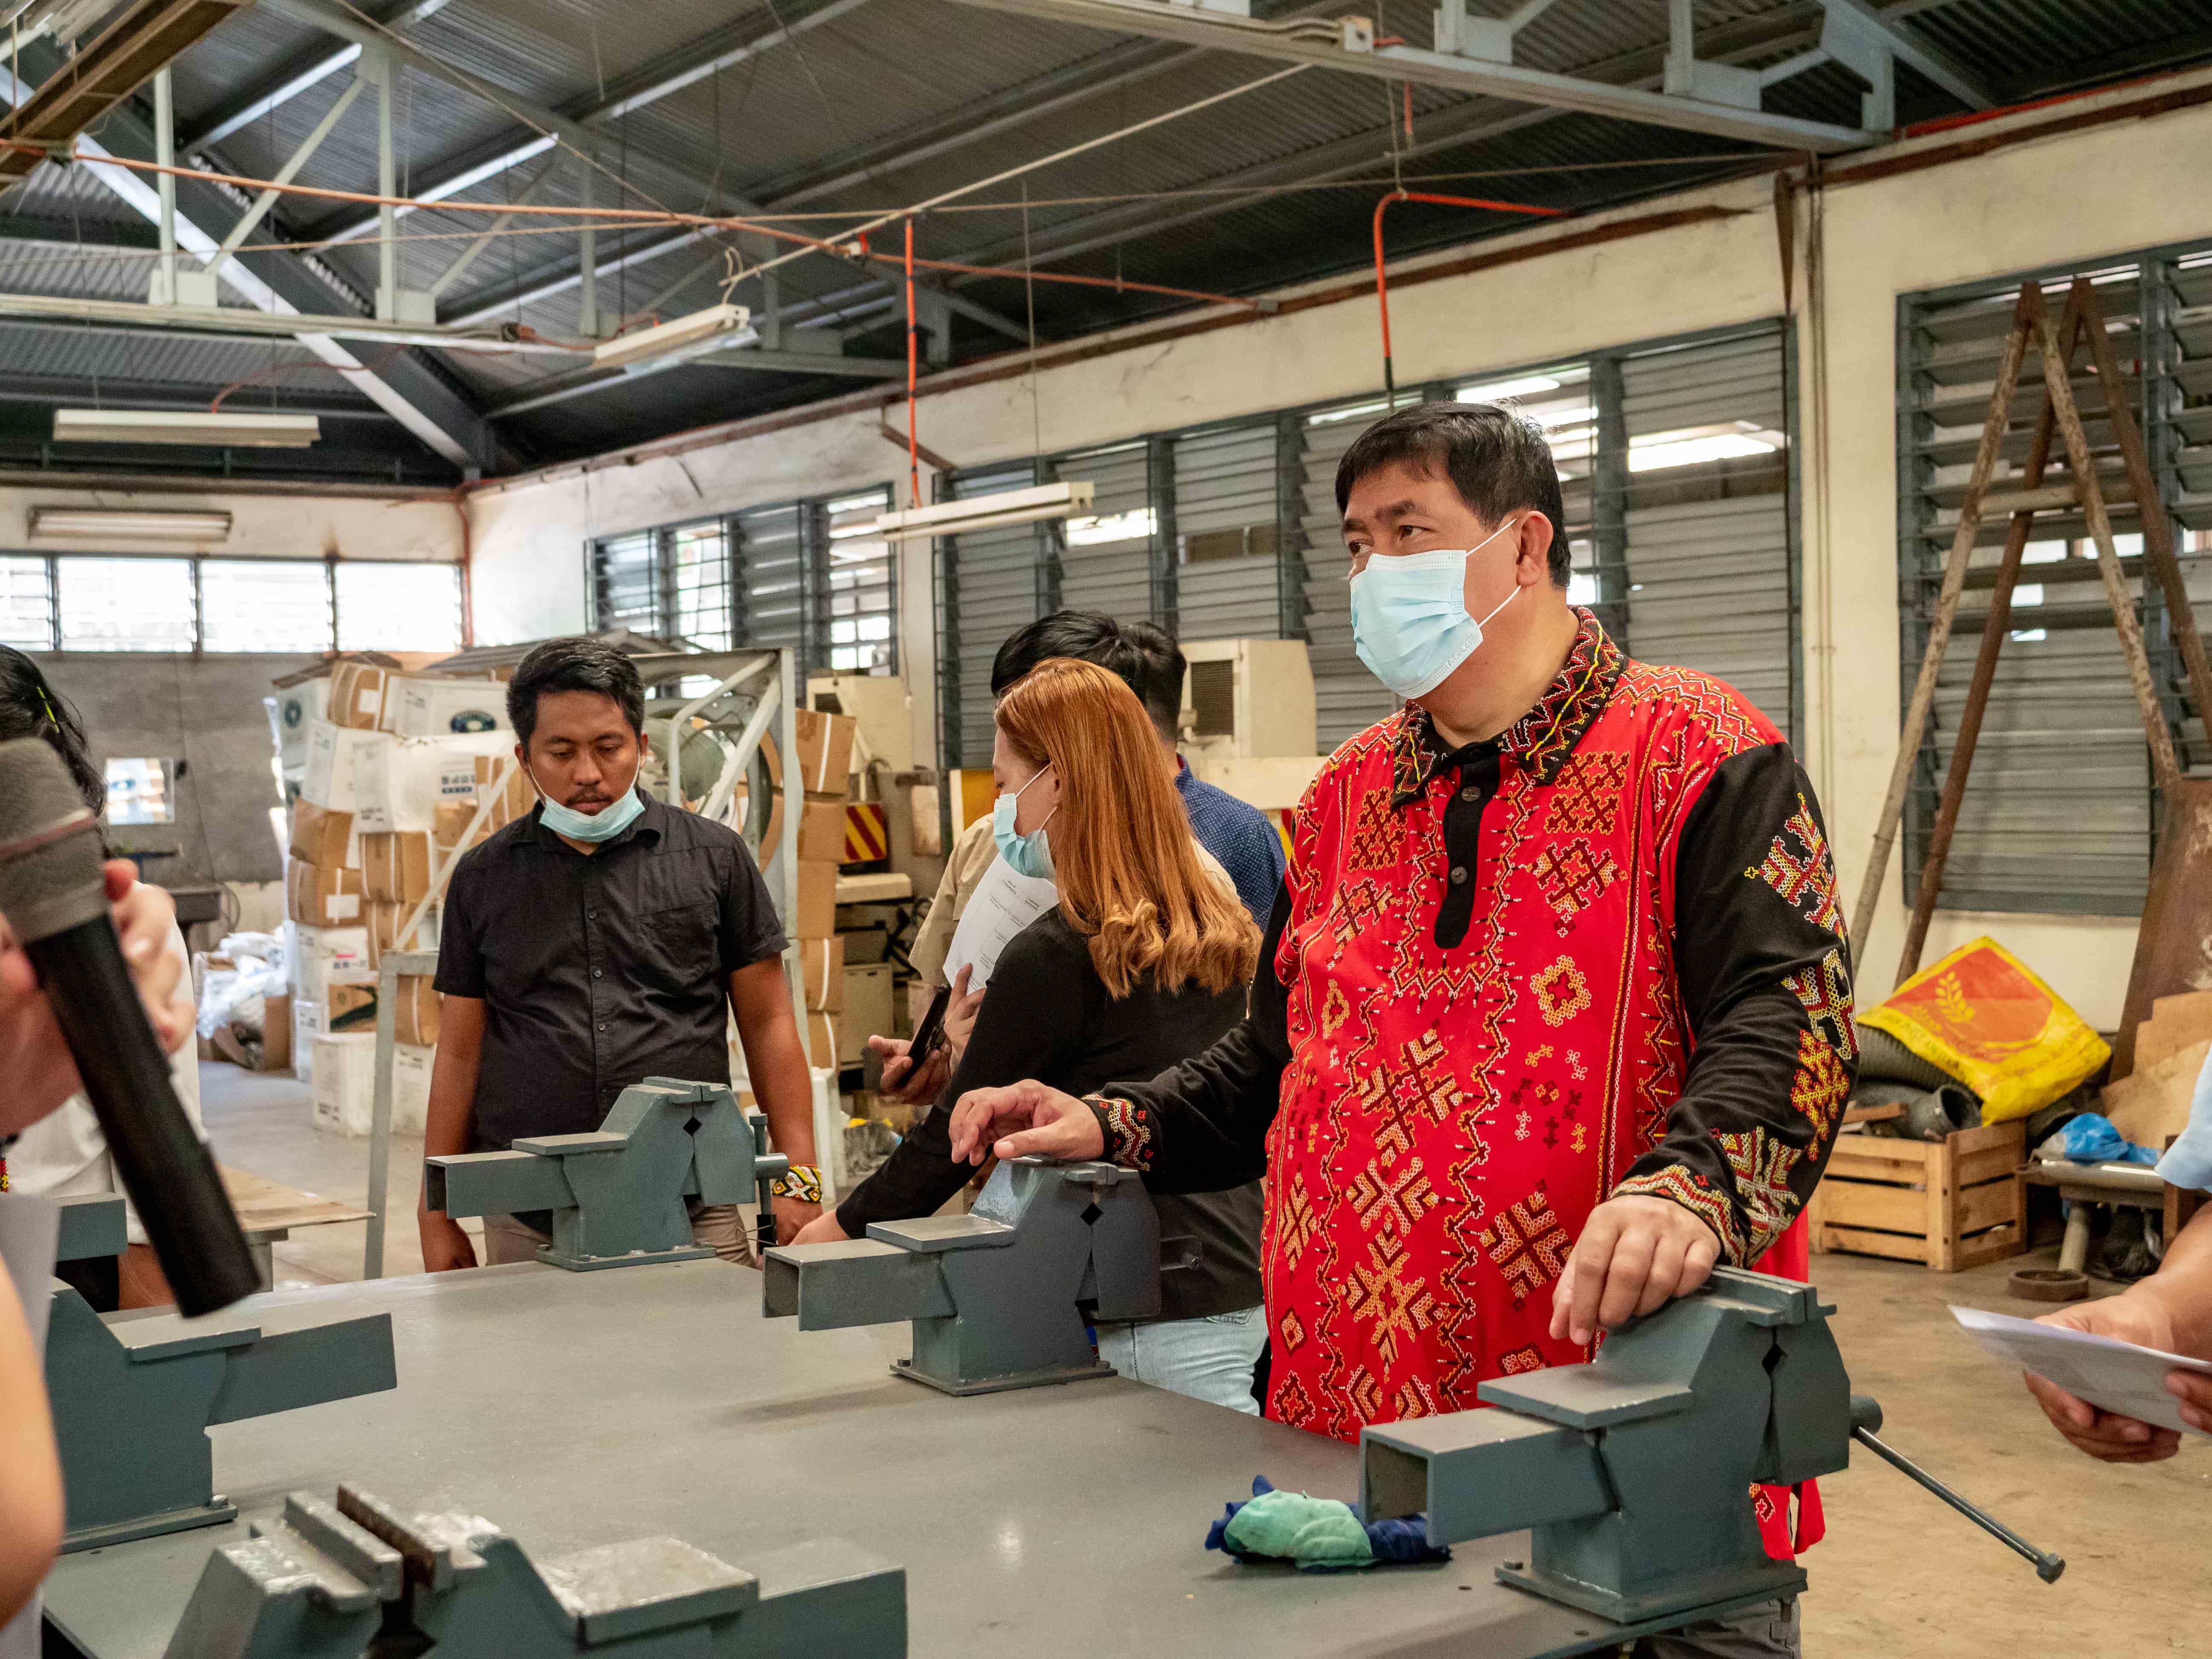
[953,405,1856,1652]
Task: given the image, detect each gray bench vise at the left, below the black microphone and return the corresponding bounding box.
[47,1199,398,1551]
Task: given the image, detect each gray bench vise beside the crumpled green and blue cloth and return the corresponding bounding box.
[1360,1267,1851,1624]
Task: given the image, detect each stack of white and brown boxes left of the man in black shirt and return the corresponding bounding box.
[270,659,515,1135]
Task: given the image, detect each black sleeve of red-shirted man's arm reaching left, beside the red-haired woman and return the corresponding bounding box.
[1089,887,1289,1192]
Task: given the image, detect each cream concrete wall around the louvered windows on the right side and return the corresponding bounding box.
[469,75,2212,1026]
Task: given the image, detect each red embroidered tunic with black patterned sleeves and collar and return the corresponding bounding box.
[1097,613,1856,1495]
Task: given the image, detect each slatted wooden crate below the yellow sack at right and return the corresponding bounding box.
[1810,1119,2029,1274]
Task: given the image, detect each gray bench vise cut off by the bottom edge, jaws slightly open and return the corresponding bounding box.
[166,1487,907,1659]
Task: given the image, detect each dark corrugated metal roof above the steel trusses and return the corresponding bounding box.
[0,0,2212,477]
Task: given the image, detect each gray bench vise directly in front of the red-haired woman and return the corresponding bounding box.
[761,1157,1190,1394]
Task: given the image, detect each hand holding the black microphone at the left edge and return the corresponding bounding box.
[0,858,192,1135]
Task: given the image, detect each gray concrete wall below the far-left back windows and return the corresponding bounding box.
[38,650,305,882]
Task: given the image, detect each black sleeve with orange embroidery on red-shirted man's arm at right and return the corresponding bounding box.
[1615,743,1858,1267]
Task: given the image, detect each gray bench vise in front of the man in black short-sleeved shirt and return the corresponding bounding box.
[422,1077,790,1272]
